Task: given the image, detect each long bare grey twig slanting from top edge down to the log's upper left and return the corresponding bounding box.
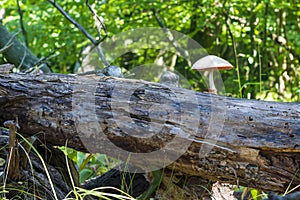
[48,0,110,67]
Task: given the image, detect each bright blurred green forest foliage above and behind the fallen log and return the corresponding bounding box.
[0,0,300,102]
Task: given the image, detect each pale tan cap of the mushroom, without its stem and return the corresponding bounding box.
[192,55,233,71]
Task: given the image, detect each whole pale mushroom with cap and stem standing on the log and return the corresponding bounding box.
[192,55,233,94]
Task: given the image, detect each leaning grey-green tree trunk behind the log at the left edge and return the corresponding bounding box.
[0,23,50,73]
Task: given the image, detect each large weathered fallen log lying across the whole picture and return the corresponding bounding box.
[0,74,300,195]
